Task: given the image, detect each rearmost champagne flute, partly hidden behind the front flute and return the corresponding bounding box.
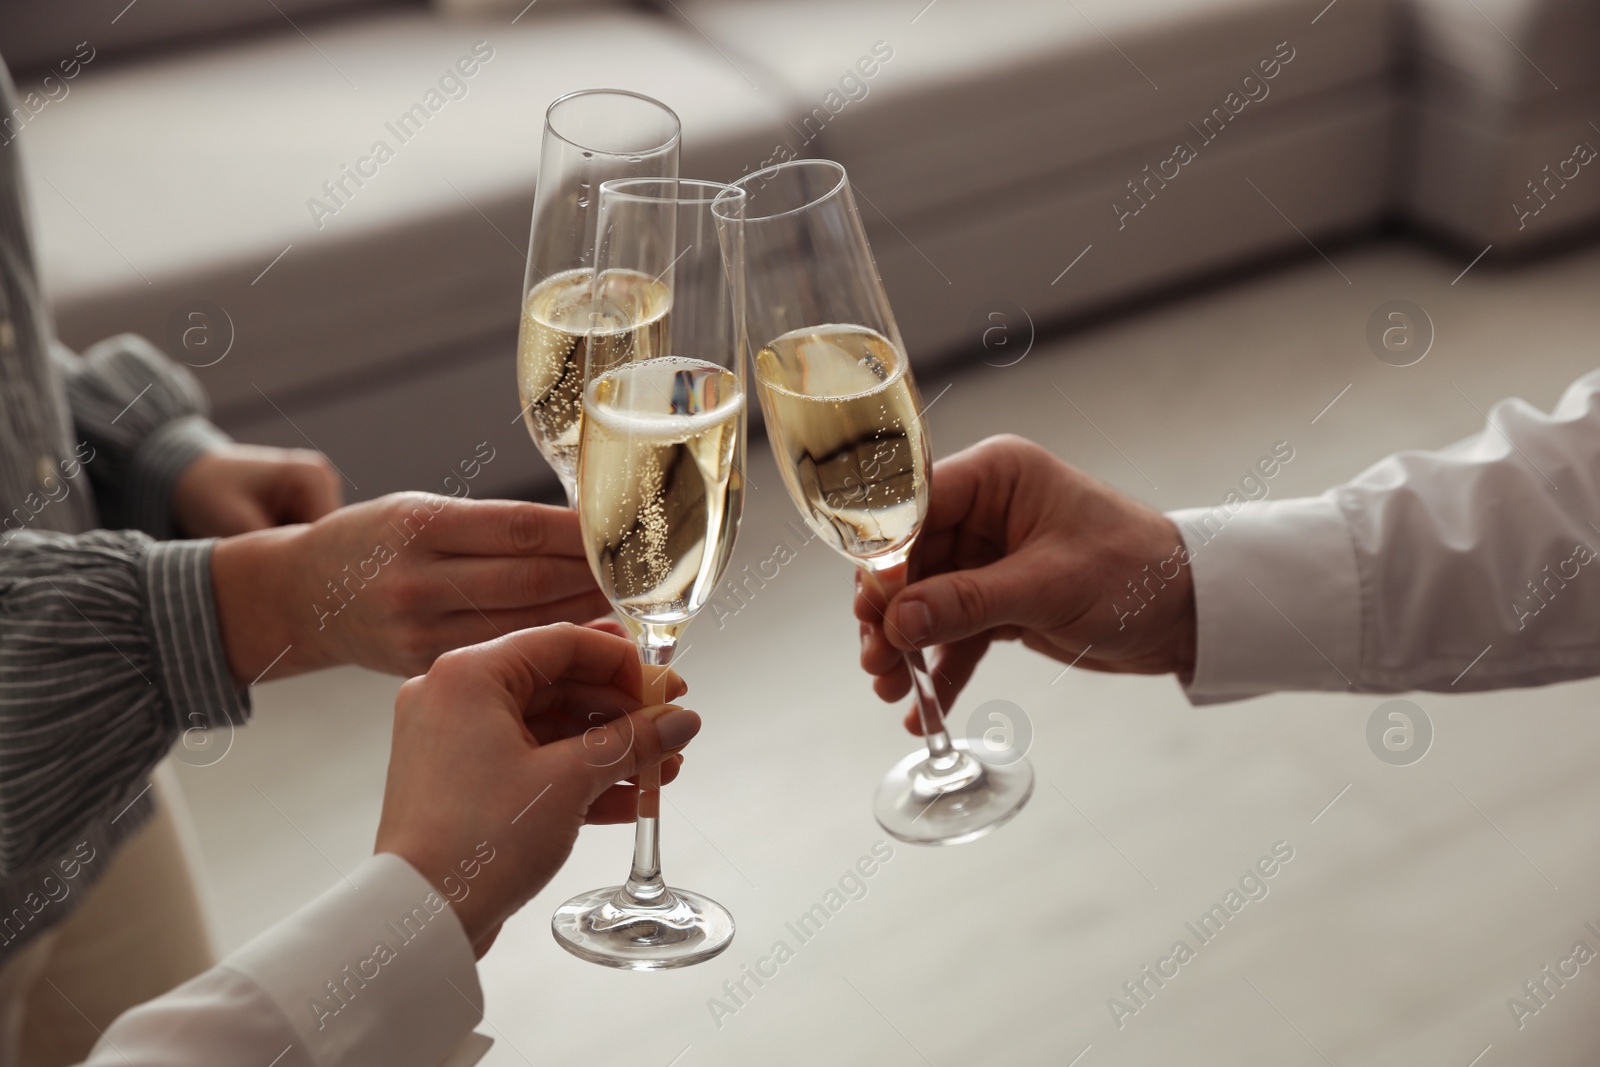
[517,90,680,507]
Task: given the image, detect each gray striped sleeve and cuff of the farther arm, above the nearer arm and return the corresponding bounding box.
[51,334,229,537]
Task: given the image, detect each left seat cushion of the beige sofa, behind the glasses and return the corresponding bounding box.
[22,10,796,414]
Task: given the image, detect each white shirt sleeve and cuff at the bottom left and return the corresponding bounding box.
[85,854,488,1067]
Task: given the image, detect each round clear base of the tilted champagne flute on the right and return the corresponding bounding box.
[872,741,1034,845]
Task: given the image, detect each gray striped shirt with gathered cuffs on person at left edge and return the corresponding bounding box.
[0,64,250,963]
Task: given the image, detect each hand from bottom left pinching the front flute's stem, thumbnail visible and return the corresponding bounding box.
[374,625,701,957]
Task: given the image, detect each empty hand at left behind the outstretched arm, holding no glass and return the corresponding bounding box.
[173,445,342,537]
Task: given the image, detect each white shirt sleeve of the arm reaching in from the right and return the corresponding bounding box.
[1171,371,1600,704]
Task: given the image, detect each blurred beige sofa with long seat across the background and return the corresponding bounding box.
[0,0,1600,498]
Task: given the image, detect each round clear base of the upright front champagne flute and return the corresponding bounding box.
[550,886,733,971]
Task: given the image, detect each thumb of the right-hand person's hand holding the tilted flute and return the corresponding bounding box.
[883,555,1048,649]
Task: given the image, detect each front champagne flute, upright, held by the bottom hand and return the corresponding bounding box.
[550,178,746,971]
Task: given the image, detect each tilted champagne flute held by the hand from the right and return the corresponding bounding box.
[718,160,1034,845]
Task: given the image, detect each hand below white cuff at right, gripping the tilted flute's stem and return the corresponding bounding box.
[854,435,1195,733]
